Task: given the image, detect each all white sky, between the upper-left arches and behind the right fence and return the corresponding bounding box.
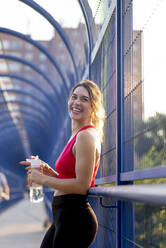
[0,0,166,118]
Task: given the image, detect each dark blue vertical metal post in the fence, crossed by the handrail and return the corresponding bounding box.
[116,0,123,248]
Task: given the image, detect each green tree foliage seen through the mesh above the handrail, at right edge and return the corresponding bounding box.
[135,113,166,169]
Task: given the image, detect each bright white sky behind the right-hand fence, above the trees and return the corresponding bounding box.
[133,0,166,119]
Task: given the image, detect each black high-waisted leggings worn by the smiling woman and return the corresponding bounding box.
[40,194,98,248]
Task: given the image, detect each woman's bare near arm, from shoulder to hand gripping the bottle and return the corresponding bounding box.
[30,130,96,194]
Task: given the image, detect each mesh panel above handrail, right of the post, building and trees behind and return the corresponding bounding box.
[123,0,166,171]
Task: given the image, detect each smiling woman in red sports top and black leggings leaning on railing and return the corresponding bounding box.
[21,80,104,248]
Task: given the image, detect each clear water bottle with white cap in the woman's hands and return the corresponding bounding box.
[26,156,44,203]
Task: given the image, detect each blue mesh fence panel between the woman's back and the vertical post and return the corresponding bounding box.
[90,4,116,248]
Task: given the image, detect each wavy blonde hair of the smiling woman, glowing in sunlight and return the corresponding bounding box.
[70,79,105,141]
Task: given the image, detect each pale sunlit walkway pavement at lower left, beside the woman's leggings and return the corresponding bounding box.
[0,196,47,248]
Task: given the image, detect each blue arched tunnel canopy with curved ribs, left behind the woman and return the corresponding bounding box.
[0,0,92,211]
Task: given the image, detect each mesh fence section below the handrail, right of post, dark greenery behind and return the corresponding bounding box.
[134,203,166,248]
